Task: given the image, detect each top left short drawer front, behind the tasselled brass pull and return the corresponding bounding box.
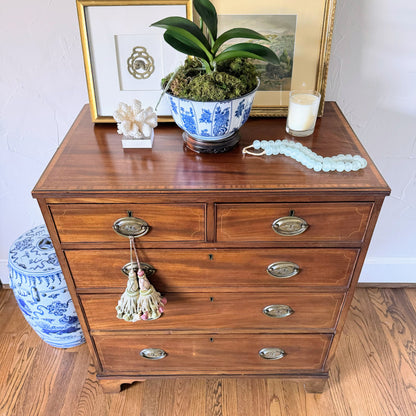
[50,204,205,244]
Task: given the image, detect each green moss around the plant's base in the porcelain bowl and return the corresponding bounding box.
[162,58,257,101]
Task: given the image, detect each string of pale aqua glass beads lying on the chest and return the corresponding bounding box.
[243,139,367,172]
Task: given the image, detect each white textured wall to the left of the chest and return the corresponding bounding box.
[0,0,88,283]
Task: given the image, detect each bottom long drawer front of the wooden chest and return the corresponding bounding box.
[94,334,331,375]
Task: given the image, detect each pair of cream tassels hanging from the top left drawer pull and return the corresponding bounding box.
[116,237,167,322]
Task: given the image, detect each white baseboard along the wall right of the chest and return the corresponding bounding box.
[359,257,416,283]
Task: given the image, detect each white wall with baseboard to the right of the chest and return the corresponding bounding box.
[327,0,416,283]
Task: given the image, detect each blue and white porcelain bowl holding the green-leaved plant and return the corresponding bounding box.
[167,80,259,148]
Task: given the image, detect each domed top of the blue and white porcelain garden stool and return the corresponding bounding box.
[9,225,61,275]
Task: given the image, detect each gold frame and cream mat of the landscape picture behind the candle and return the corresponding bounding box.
[211,0,336,117]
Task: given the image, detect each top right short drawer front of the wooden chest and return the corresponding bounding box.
[216,202,373,243]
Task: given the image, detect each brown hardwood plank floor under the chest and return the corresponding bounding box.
[0,288,416,416]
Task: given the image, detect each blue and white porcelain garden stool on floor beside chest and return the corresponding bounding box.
[9,225,85,348]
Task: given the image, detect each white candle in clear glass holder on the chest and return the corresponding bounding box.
[286,91,321,137]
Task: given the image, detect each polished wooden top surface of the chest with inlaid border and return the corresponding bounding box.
[33,102,389,198]
